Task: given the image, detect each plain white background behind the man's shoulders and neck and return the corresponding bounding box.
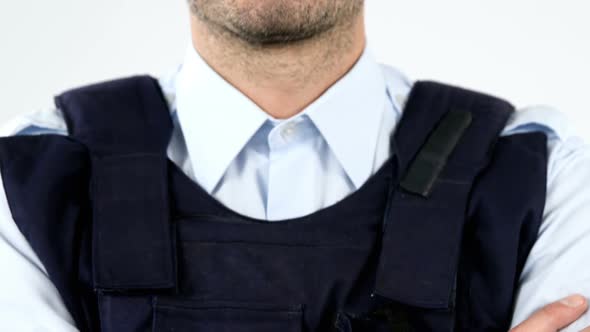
[0,0,590,141]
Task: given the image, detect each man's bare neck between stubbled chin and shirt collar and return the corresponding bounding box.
[191,14,365,119]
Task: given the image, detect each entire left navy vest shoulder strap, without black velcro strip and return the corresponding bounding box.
[55,76,176,291]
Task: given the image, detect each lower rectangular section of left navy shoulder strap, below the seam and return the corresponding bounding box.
[92,154,175,290]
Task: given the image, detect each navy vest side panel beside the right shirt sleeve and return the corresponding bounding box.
[457,133,548,331]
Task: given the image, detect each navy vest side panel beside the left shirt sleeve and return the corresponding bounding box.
[0,135,96,331]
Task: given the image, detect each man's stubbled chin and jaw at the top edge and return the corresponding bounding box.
[188,0,364,47]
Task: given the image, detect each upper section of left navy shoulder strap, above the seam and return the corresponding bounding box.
[55,76,172,157]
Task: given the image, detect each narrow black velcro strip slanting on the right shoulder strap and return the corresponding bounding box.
[400,111,473,197]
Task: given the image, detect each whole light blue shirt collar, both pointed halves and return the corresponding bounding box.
[175,45,394,193]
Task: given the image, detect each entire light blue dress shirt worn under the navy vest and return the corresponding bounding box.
[0,47,590,332]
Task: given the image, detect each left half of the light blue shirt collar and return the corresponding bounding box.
[176,45,268,193]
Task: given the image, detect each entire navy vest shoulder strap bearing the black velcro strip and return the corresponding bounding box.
[375,82,514,310]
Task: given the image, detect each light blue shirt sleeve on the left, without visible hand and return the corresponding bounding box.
[0,109,77,332]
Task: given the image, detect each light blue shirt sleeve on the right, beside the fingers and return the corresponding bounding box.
[512,109,590,331]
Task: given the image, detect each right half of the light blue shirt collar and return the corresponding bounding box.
[305,48,387,188]
